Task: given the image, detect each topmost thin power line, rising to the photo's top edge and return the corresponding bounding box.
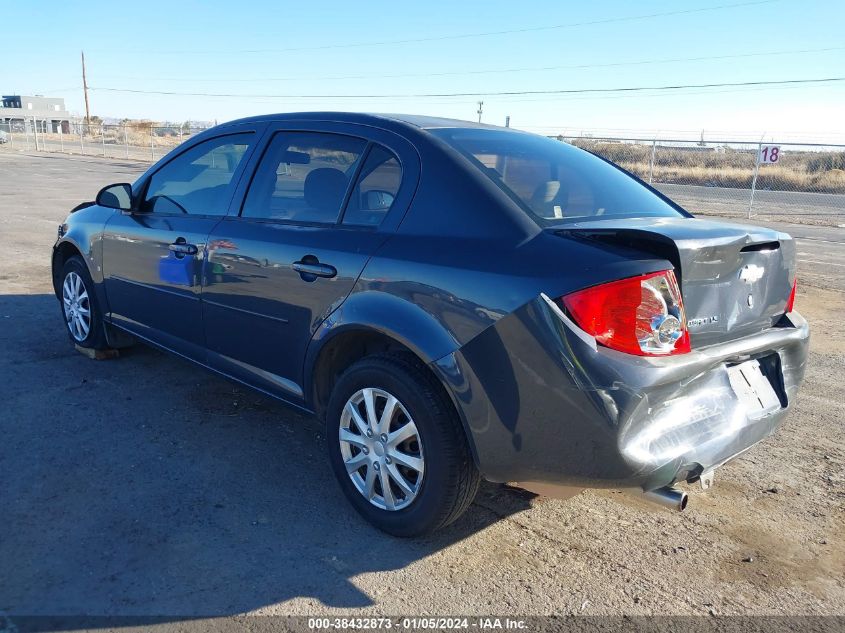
[97,0,779,55]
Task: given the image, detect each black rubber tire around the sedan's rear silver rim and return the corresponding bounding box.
[326,353,481,537]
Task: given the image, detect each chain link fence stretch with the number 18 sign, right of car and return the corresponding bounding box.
[555,136,845,226]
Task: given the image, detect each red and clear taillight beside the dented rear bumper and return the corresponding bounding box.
[561,270,690,356]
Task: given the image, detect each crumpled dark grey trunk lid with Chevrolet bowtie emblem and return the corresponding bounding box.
[549,218,795,348]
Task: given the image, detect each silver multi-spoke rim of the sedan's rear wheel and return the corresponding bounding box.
[338,387,425,511]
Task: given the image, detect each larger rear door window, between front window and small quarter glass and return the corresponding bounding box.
[241,132,367,223]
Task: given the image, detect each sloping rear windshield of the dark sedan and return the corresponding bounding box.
[430,128,683,226]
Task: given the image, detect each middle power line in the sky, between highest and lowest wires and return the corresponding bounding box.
[92,46,845,83]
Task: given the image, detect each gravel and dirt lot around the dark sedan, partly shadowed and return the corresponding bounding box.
[0,151,845,619]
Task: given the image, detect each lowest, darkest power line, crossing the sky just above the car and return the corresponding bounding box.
[89,77,845,99]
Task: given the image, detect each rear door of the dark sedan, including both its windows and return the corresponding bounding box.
[203,123,419,403]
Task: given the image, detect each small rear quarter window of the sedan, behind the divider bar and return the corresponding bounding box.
[343,145,402,226]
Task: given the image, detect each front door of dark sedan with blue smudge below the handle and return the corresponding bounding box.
[103,130,256,362]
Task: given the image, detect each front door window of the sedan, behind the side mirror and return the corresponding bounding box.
[142,133,254,215]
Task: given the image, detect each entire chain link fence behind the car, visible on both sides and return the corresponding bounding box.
[0,119,845,226]
